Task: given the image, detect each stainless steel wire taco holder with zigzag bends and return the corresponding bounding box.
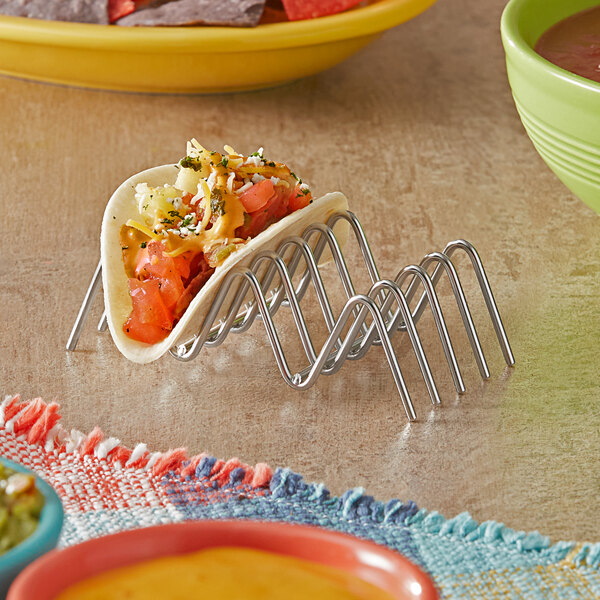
[67,211,515,421]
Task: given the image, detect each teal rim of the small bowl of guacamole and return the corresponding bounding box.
[0,456,64,571]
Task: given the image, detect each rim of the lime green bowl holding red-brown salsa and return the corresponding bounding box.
[500,0,600,93]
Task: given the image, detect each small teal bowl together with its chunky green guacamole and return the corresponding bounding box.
[0,457,63,598]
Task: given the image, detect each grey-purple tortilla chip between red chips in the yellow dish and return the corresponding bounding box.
[116,0,265,27]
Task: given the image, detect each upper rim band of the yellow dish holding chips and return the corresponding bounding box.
[0,0,437,53]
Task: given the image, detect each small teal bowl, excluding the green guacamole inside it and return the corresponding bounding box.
[0,457,63,598]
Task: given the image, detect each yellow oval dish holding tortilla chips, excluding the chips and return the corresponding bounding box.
[0,0,435,93]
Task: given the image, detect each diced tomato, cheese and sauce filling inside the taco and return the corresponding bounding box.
[120,140,312,344]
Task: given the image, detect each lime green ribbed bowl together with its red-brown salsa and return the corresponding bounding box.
[501,0,600,213]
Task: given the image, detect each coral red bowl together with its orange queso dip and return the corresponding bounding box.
[7,520,439,600]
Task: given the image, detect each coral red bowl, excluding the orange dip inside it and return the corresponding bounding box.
[7,521,439,600]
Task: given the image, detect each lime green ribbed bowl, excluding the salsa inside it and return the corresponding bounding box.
[501,0,600,214]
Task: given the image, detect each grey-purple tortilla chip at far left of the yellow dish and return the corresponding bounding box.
[0,0,108,25]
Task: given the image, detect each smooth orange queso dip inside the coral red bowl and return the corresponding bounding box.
[56,547,393,600]
